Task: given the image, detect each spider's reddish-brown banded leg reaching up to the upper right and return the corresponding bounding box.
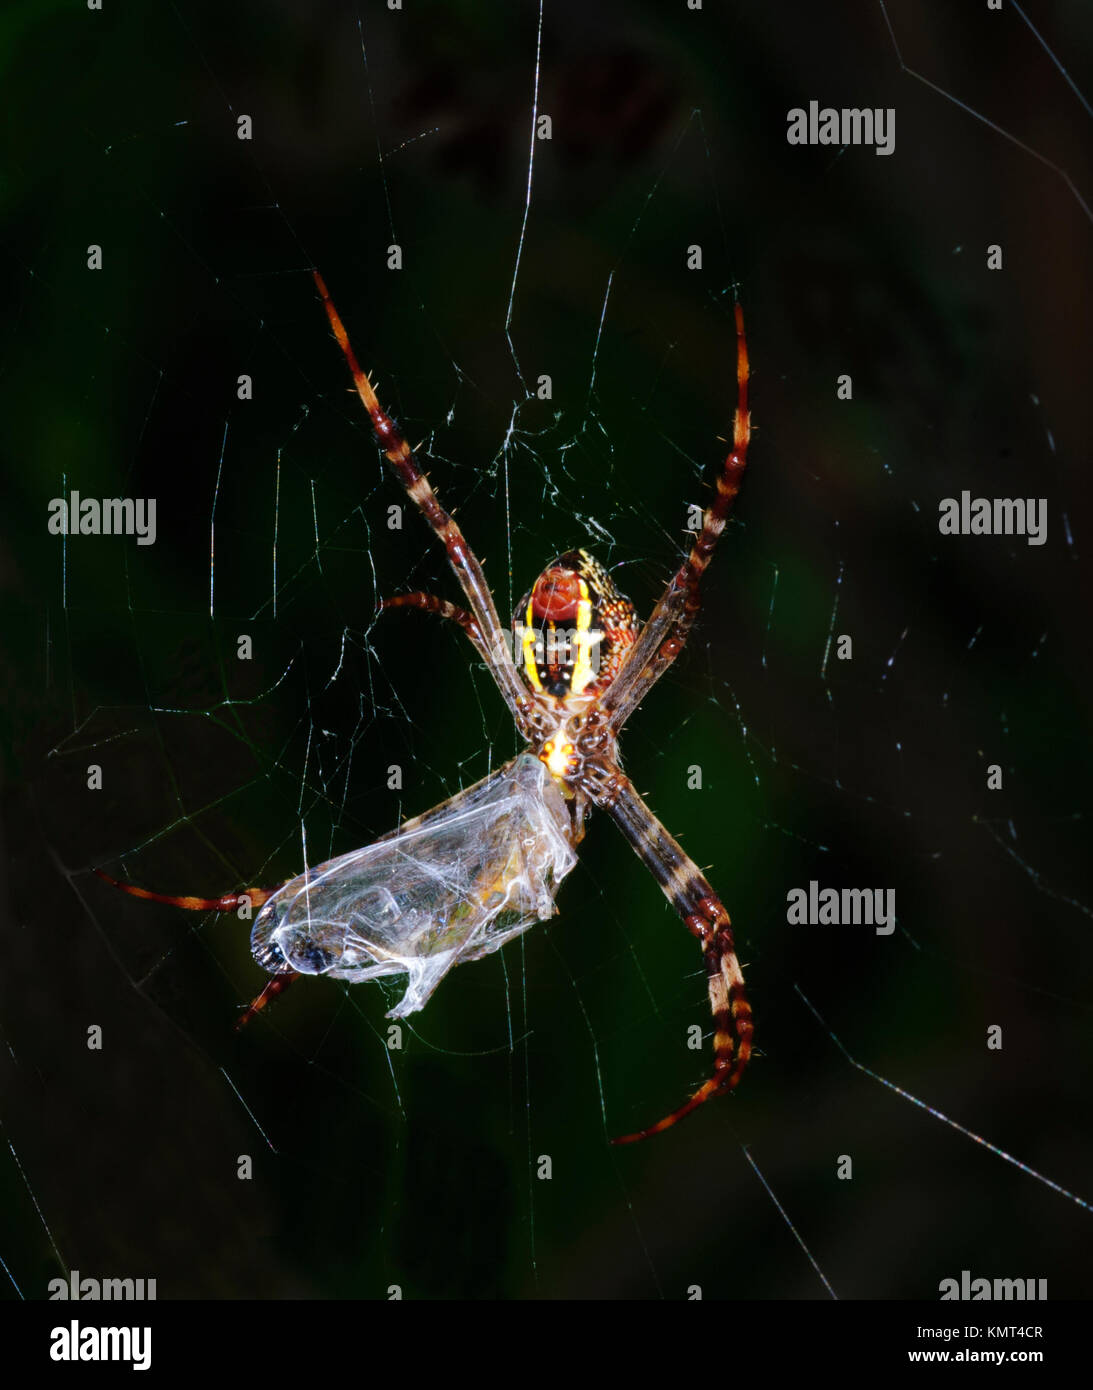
[586,304,751,735]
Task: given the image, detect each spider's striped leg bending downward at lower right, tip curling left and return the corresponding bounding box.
[586,766,754,1144]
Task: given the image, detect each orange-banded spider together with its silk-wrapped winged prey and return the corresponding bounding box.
[95,271,752,1144]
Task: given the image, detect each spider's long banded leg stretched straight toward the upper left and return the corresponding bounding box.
[314,271,531,724]
